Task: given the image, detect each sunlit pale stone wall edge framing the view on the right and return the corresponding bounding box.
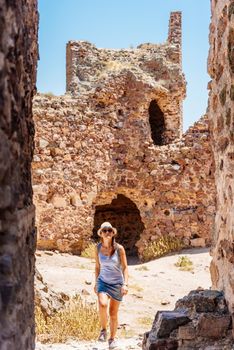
[209,0,234,320]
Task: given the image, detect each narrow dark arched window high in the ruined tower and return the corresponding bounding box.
[149,100,166,146]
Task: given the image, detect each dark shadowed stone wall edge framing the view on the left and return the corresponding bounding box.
[0,0,38,350]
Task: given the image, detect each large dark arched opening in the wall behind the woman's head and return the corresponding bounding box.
[93,194,144,255]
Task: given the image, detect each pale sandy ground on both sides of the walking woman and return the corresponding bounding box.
[36,248,211,350]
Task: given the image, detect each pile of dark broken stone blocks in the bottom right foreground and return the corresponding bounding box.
[143,290,234,350]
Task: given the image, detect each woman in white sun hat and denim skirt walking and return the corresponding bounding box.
[94,222,128,349]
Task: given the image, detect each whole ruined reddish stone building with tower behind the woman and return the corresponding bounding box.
[33,12,214,255]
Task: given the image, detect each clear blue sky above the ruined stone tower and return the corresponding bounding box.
[37,0,210,130]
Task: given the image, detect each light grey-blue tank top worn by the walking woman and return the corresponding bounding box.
[97,243,124,284]
